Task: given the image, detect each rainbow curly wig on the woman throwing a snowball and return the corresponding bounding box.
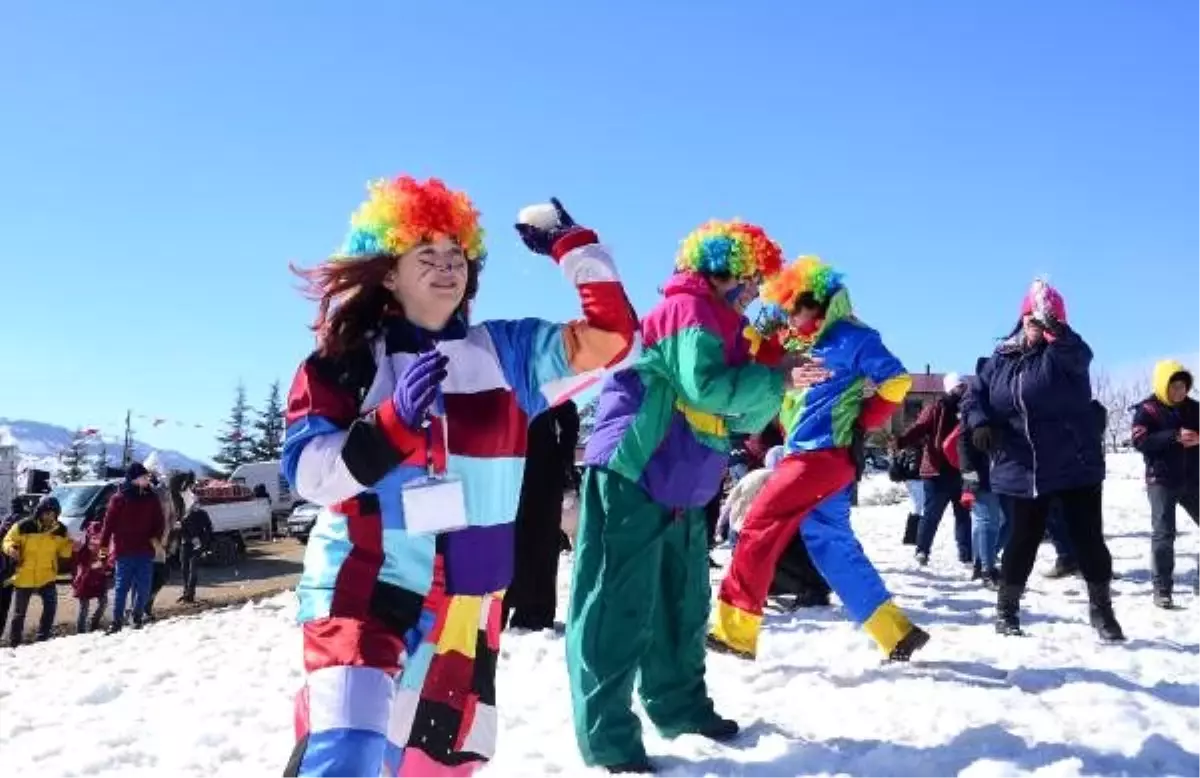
[332,175,486,262]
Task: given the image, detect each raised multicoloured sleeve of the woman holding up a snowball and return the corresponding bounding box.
[486,229,640,417]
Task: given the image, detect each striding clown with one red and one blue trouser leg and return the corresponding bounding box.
[709,257,929,659]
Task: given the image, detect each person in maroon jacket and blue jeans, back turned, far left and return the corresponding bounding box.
[100,462,166,633]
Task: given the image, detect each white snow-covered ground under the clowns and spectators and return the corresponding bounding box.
[0,456,1200,778]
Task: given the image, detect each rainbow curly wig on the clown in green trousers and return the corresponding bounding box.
[676,220,784,280]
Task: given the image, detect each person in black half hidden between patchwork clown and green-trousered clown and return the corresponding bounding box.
[503,400,580,630]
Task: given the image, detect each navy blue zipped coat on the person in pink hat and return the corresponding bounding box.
[961,325,1104,497]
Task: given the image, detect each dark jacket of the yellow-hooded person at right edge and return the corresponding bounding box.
[1133,393,1200,491]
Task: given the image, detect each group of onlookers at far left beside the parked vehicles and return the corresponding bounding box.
[0,463,212,646]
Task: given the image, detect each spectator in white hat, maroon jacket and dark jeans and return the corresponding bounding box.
[895,373,972,565]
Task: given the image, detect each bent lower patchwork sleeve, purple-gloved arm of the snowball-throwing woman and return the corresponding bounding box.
[282,355,420,505]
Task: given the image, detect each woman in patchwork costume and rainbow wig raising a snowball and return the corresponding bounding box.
[283,176,637,778]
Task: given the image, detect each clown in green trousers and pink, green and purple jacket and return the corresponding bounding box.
[566,221,784,772]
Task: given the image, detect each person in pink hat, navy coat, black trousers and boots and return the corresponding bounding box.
[962,280,1124,642]
